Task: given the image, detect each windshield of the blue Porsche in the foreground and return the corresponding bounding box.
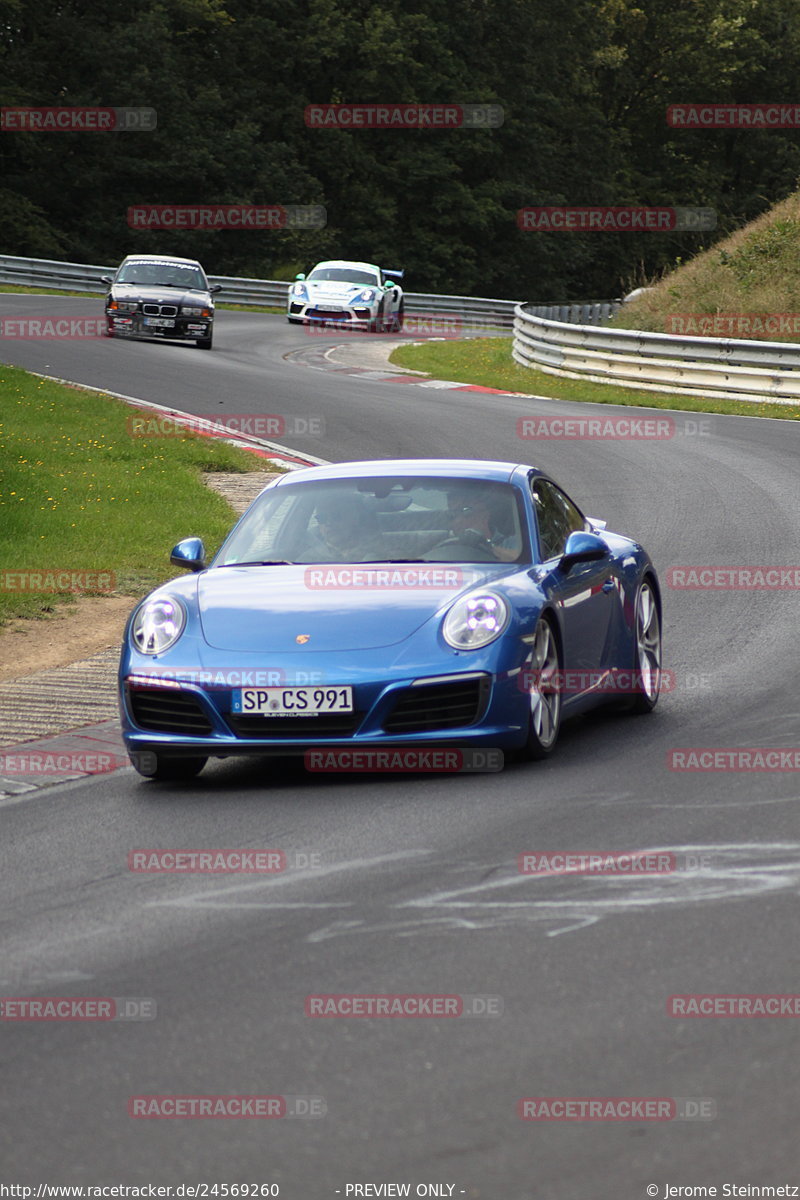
[212,476,530,566]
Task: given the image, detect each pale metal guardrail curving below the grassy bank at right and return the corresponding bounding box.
[512,304,800,403]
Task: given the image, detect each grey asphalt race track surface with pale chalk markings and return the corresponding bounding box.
[0,296,800,1200]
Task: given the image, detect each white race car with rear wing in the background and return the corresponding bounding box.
[287,260,403,334]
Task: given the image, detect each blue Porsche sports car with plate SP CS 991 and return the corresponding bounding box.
[120,460,661,779]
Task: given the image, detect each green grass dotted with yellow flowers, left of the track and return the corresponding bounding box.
[0,364,276,625]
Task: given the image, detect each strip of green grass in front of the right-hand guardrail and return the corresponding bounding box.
[391,337,800,421]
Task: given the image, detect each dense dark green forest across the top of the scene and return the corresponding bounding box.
[0,0,800,301]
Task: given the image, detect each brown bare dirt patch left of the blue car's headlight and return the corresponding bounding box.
[0,596,137,679]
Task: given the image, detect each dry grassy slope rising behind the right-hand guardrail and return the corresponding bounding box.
[612,192,800,342]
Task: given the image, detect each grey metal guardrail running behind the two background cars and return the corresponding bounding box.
[0,254,615,329]
